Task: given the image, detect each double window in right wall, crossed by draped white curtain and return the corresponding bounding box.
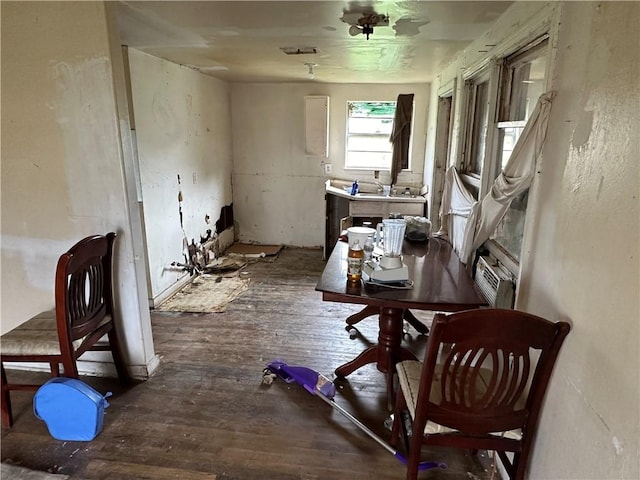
[458,35,550,275]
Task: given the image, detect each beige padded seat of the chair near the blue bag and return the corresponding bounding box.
[0,310,111,355]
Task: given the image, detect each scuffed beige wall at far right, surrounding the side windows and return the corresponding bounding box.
[424,2,640,480]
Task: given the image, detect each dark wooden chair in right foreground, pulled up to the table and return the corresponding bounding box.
[391,309,570,480]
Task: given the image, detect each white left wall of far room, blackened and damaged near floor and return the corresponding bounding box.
[129,49,232,299]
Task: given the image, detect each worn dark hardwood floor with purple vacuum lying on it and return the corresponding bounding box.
[1,248,497,480]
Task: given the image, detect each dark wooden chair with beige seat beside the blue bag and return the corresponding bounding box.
[0,232,130,427]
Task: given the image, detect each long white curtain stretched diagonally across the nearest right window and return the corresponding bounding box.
[458,92,555,264]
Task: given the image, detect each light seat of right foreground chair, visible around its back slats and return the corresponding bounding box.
[396,360,522,440]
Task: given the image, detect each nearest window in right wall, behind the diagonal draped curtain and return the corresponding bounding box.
[491,38,548,263]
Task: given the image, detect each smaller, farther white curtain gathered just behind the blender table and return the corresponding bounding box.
[434,167,477,256]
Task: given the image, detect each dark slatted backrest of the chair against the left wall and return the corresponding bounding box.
[55,232,116,350]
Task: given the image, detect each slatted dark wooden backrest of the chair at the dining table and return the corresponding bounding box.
[415,309,570,435]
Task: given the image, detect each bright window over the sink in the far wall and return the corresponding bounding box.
[345,101,398,170]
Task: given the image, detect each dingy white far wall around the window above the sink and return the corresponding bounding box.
[231,82,429,247]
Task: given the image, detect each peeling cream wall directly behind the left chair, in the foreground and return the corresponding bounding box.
[1,2,154,376]
